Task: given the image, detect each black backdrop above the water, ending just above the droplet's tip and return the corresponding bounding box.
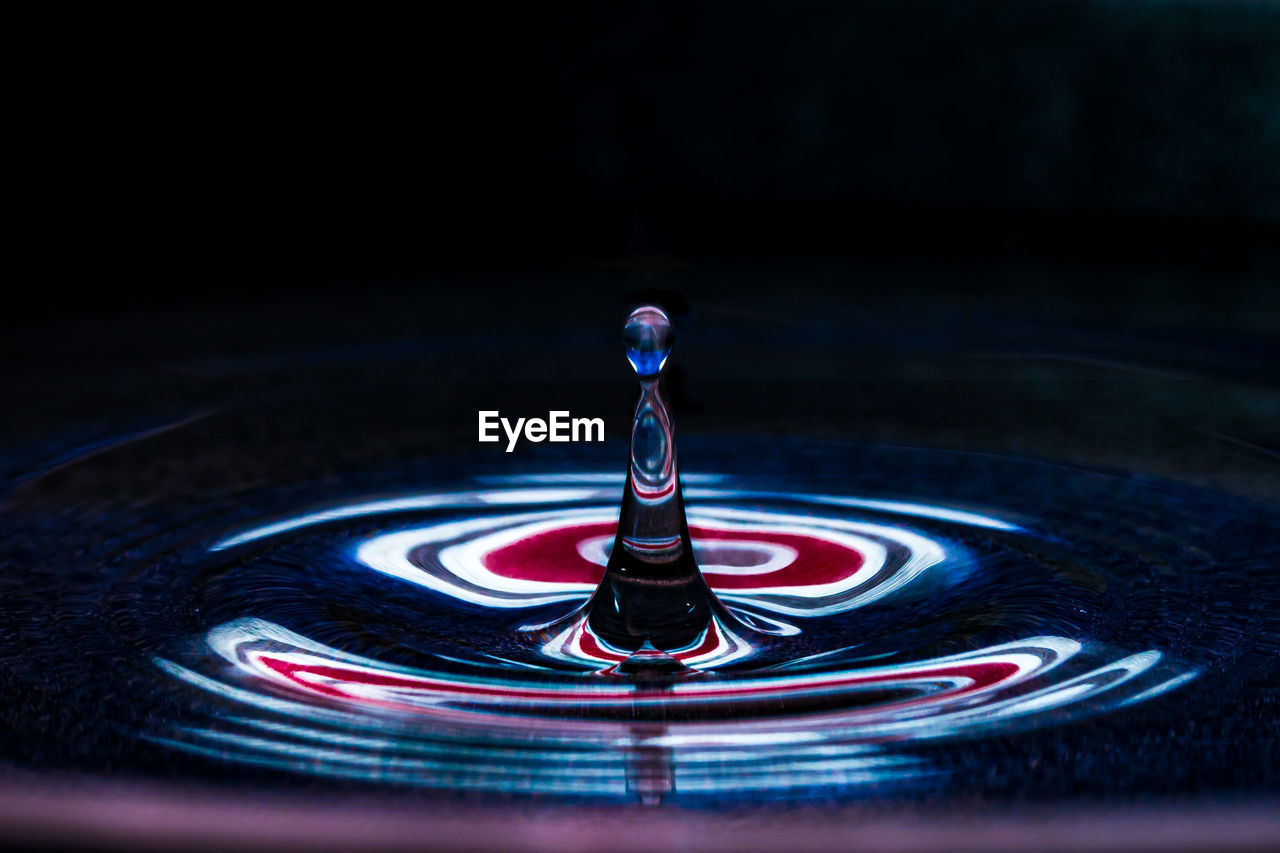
[15,0,1280,324]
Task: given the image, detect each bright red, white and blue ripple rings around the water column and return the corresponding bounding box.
[143,473,1198,802]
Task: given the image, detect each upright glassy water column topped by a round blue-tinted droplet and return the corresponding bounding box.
[586,306,737,650]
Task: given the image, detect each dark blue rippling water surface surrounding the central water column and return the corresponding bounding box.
[0,438,1280,808]
